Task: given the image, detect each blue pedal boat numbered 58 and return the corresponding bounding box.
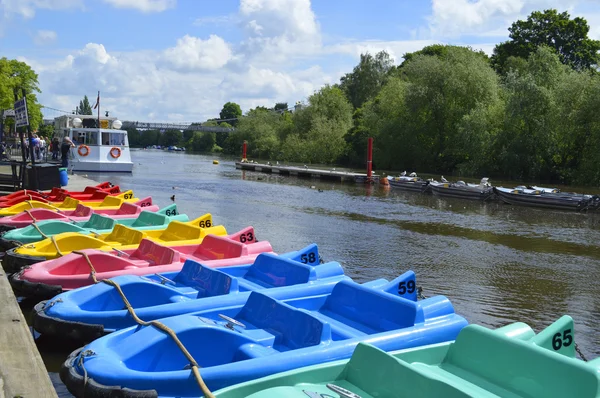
[33,244,349,342]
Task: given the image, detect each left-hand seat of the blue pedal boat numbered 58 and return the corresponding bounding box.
[174,260,238,298]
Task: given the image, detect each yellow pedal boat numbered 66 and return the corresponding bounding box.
[2,213,227,273]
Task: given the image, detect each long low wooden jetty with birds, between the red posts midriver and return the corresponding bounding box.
[235,162,379,183]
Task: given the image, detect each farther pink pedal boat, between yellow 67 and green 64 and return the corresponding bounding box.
[0,197,158,232]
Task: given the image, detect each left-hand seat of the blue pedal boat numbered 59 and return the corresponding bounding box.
[234,292,331,352]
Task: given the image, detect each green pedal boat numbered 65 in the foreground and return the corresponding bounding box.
[215,315,600,398]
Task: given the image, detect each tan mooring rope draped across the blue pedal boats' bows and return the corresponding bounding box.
[72,250,215,398]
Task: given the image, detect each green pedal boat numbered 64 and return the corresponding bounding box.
[2,204,189,248]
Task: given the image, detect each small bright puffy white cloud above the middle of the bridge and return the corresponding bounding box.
[163,35,232,71]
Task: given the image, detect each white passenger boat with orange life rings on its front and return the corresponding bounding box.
[54,115,133,173]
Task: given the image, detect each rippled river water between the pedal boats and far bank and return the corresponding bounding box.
[22,150,600,397]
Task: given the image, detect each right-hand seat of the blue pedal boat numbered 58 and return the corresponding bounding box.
[241,253,316,288]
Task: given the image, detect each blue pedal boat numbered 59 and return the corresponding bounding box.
[60,274,467,398]
